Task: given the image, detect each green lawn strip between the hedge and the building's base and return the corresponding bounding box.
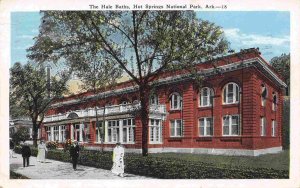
[149,150,290,170]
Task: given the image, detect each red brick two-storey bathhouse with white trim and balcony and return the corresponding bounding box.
[42,49,286,156]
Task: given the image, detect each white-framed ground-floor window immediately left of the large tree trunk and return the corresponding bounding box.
[122,119,135,143]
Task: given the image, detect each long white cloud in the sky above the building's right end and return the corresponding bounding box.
[224,28,290,46]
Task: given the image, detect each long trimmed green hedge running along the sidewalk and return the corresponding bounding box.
[16,148,289,179]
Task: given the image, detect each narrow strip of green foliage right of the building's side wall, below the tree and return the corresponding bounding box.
[282,98,290,150]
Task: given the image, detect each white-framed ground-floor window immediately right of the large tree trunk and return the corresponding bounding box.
[149,119,162,144]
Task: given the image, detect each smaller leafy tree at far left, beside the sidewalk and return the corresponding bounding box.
[10,63,69,146]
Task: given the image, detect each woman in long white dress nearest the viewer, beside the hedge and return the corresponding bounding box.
[111,142,124,177]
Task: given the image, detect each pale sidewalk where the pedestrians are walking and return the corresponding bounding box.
[9,153,151,179]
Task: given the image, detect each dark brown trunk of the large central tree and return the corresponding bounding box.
[140,85,149,156]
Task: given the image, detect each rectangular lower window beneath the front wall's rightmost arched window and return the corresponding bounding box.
[223,115,240,136]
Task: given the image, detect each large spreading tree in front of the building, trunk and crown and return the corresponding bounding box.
[28,11,228,156]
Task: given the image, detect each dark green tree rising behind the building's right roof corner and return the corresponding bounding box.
[270,54,290,95]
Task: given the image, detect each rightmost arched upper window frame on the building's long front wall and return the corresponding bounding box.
[222,82,241,105]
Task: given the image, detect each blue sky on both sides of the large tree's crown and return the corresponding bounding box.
[11,11,290,64]
